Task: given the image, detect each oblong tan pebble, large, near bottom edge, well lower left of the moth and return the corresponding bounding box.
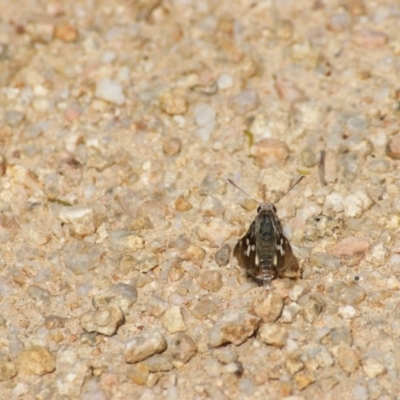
[124,331,167,364]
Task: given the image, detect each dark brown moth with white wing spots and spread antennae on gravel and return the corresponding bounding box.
[227,176,304,287]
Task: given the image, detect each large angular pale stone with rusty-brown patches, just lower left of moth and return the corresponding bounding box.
[208,310,260,347]
